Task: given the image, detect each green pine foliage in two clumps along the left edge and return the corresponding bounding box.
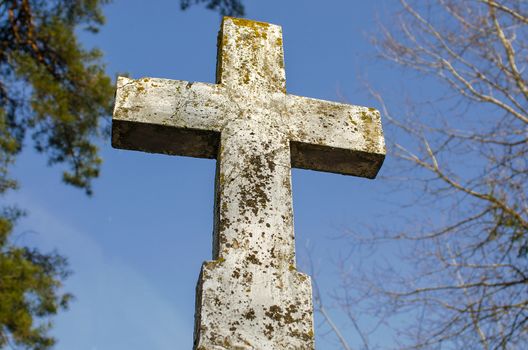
[0,0,113,349]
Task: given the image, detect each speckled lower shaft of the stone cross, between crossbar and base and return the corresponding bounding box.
[213,126,295,269]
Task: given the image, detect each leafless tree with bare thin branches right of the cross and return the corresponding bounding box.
[328,0,528,350]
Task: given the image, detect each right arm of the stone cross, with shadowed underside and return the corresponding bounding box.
[283,95,385,178]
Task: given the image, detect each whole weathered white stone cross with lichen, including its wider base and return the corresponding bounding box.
[112,17,385,350]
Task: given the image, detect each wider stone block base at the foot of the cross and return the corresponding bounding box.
[194,259,314,350]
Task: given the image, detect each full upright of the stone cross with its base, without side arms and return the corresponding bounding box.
[195,19,313,349]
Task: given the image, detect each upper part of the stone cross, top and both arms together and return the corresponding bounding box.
[112,17,385,178]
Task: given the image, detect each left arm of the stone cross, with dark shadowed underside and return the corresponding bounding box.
[112,77,229,158]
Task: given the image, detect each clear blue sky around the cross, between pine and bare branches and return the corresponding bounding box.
[8,0,412,350]
